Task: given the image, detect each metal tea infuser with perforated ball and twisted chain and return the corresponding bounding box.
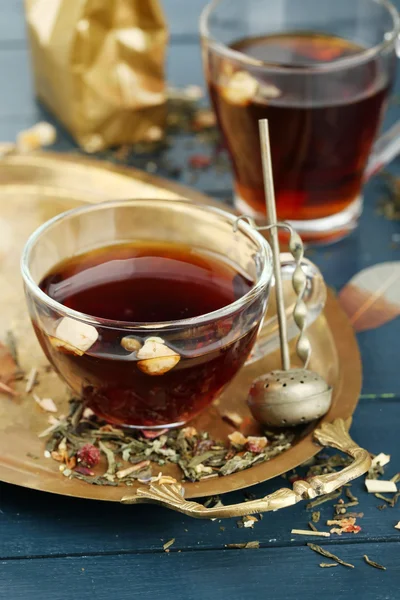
[242,119,332,427]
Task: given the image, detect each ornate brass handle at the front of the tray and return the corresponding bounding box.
[121,419,371,519]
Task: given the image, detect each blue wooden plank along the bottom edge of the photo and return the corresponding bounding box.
[0,541,400,600]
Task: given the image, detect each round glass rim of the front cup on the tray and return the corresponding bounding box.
[20,198,272,330]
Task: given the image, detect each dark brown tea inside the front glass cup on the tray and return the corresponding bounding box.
[35,243,258,428]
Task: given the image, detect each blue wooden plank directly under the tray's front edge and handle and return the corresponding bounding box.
[0,398,400,559]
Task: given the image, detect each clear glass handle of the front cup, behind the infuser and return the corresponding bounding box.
[246,252,326,365]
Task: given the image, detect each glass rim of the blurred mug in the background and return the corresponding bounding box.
[200,0,400,75]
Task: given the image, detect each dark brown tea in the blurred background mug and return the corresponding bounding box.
[208,33,389,220]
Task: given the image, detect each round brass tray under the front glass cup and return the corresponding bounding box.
[0,153,368,517]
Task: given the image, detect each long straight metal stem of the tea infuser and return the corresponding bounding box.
[258,119,290,371]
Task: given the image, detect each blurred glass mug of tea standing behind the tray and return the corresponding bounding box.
[200,0,400,242]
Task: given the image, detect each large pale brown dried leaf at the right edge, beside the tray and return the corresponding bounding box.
[339,261,400,331]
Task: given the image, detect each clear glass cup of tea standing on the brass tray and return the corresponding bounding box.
[21,200,325,429]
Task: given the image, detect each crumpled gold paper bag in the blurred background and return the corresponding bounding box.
[25,0,168,152]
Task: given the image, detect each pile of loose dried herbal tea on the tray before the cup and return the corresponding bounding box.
[43,400,294,485]
